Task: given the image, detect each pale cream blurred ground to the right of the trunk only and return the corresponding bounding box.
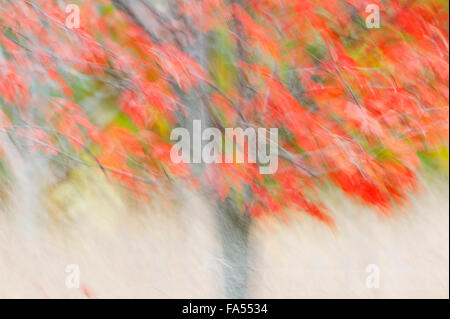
[251,179,449,298]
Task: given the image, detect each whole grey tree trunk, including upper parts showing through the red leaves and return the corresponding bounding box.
[113,0,250,298]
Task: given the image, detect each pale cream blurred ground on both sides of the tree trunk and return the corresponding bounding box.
[0,169,449,298]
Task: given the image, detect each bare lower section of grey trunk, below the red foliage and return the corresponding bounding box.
[216,198,250,299]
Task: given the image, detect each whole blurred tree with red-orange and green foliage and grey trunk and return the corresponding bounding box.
[0,0,449,297]
